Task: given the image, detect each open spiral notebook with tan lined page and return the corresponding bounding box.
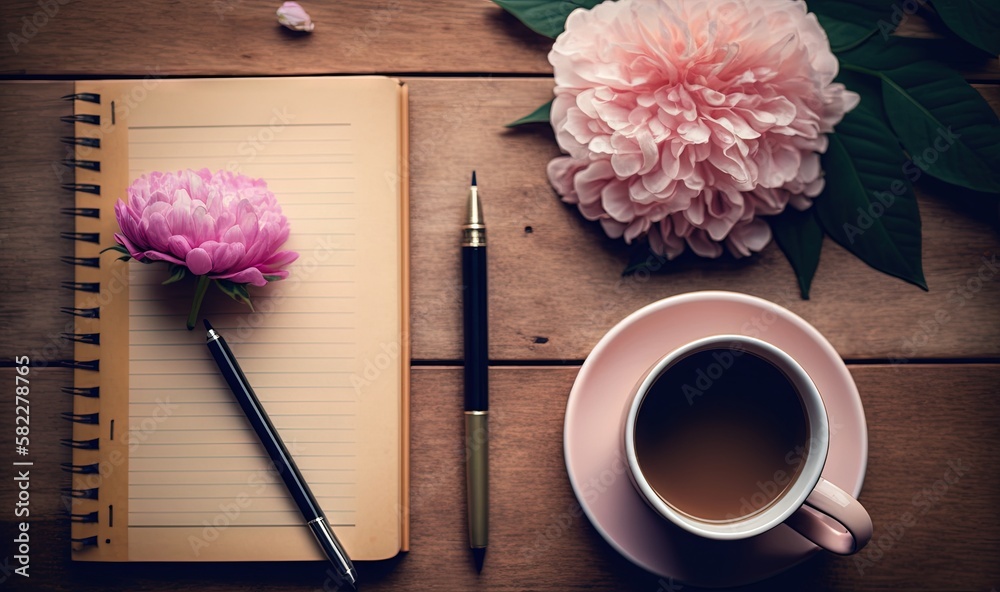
[64,77,410,561]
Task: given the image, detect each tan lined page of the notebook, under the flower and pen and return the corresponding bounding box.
[118,79,410,559]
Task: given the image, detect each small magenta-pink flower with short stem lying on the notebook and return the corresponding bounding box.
[114,169,299,329]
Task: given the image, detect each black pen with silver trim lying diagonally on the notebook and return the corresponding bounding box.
[205,320,358,589]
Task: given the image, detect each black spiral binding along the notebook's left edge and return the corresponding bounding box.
[60,92,101,550]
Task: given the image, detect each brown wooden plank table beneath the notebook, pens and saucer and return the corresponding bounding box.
[0,0,1000,592]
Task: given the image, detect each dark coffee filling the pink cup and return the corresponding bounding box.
[634,348,809,522]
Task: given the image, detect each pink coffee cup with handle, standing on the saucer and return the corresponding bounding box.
[622,335,872,555]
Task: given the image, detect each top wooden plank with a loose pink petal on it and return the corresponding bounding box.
[0,0,1000,80]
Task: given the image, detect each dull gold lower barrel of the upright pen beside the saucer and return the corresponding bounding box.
[465,411,490,549]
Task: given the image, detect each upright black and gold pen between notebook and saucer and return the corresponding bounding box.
[462,171,490,571]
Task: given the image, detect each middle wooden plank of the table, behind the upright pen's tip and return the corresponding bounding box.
[0,77,1000,361]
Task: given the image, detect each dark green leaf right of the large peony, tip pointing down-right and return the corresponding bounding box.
[813,109,927,290]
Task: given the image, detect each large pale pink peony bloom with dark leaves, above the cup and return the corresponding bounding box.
[548,0,859,258]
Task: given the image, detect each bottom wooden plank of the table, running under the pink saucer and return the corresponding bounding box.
[0,364,1000,592]
